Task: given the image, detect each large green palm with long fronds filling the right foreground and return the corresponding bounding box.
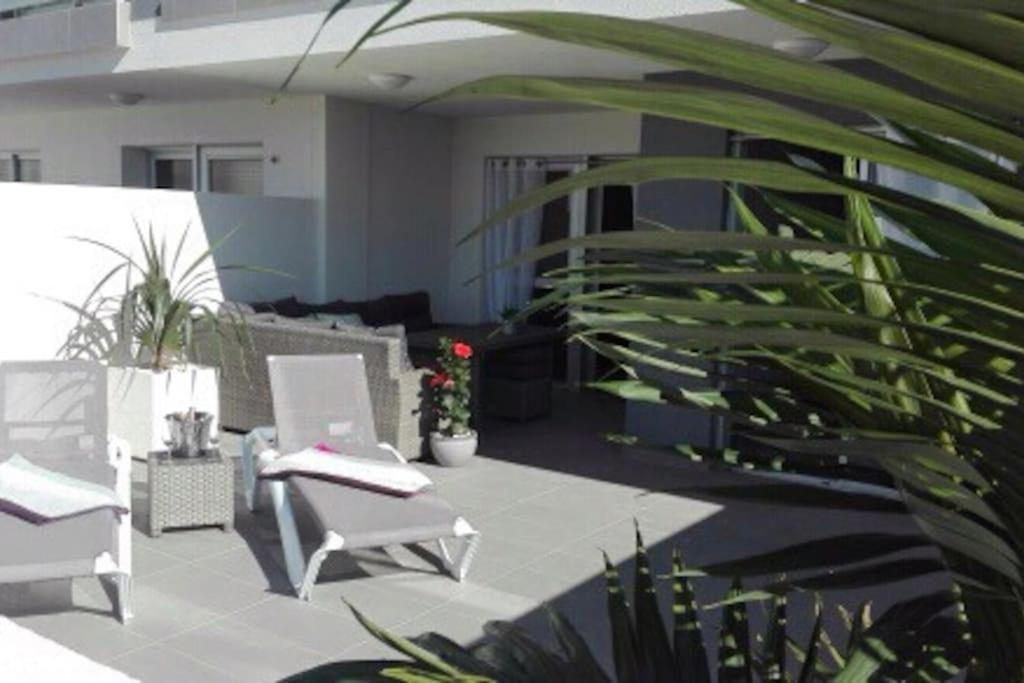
[290,0,1024,681]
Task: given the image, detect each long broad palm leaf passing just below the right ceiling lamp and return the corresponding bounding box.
[387,11,1024,159]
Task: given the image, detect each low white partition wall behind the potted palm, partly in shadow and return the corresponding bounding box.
[0,183,316,360]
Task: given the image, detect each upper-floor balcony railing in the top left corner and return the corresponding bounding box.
[0,0,131,61]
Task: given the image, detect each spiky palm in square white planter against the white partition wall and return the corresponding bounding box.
[62,226,251,455]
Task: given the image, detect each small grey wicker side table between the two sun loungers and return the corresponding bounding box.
[148,451,234,538]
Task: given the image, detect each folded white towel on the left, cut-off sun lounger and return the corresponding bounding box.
[0,455,128,524]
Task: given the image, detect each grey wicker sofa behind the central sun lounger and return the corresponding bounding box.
[197,314,429,459]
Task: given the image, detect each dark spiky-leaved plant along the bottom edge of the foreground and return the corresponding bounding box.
[287,530,967,683]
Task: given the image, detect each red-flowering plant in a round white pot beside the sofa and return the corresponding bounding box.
[430,337,477,467]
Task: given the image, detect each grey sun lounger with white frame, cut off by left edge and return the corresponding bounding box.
[0,360,132,622]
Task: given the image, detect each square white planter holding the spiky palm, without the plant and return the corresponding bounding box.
[106,366,220,459]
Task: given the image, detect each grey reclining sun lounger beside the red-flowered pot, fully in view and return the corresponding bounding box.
[243,355,479,600]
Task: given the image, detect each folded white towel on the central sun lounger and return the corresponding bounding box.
[259,449,433,498]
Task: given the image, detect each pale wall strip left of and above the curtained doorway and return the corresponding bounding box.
[448,112,640,323]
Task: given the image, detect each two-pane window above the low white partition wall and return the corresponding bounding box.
[148,145,263,195]
